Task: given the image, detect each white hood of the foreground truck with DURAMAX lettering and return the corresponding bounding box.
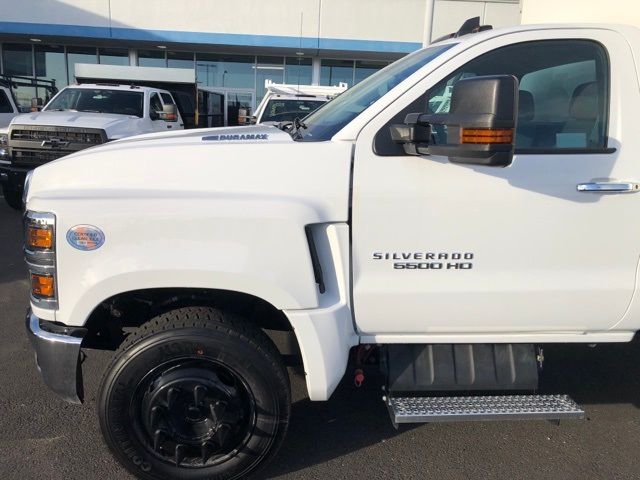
[28,125,344,207]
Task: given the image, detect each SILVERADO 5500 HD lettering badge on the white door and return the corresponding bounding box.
[373,252,473,270]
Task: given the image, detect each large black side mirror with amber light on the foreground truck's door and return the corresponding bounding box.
[391,75,518,167]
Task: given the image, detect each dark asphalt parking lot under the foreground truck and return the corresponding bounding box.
[0,202,640,480]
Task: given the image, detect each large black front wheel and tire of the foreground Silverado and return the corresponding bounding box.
[98,307,291,480]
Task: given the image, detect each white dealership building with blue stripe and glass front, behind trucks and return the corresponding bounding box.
[0,0,521,107]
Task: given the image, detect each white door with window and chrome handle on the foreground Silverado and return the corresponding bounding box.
[352,29,640,341]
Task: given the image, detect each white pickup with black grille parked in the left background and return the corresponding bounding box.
[0,84,184,209]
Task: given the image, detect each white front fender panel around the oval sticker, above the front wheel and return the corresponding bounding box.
[45,198,319,326]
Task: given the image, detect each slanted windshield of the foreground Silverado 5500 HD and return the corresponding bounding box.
[294,43,456,142]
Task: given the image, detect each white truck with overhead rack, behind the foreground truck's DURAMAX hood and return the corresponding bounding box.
[251,79,348,124]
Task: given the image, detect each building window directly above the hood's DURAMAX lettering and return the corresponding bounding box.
[196,53,255,90]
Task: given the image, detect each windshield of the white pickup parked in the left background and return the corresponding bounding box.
[45,88,144,118]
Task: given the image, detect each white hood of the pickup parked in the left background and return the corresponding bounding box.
[11,110,140,138]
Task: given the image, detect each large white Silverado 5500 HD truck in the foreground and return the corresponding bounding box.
[25,21,640,479]
